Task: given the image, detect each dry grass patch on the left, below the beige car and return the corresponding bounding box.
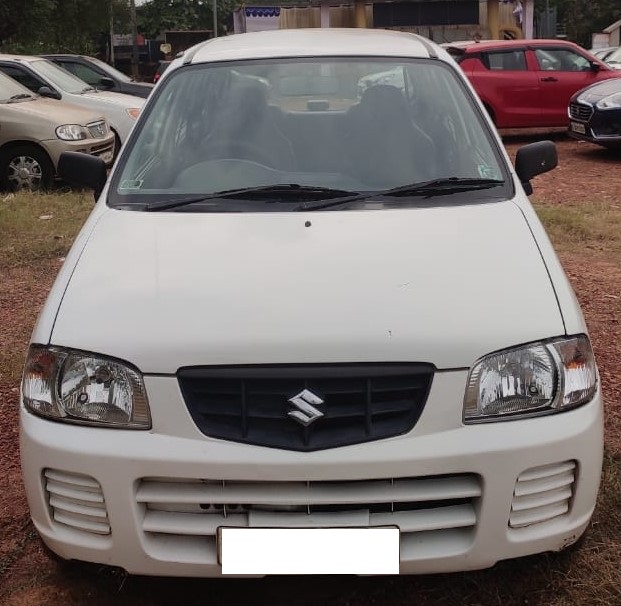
[0,192,93,267]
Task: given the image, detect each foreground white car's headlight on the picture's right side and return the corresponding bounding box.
[464,335,597,423]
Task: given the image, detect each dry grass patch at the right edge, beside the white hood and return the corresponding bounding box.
[534,201,621,256]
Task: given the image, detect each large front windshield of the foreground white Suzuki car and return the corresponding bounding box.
[108,57,510,211]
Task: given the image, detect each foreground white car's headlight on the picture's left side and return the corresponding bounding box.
[22,345,151,429]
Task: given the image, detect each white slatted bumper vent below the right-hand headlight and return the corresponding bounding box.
[509,461,576,528]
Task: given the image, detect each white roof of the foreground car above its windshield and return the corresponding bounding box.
[181,28,448,64]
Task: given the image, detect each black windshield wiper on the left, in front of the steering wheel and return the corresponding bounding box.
[144,183,353,212]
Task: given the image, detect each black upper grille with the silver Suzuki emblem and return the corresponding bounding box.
[177,364,434,451]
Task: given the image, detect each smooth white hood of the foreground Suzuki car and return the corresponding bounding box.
[51,202,564,373]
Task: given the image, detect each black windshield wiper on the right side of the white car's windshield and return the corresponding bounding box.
[293,177,504,211]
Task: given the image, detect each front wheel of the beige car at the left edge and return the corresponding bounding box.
[0,144,54,191]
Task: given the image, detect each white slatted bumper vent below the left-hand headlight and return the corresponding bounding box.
[43,469,111,535]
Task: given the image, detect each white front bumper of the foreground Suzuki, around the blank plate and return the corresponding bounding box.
[21,371,603,577]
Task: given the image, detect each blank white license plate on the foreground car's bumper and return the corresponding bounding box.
[218,527,399,575]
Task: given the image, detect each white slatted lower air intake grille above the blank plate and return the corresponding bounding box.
[136,474,481,563]
